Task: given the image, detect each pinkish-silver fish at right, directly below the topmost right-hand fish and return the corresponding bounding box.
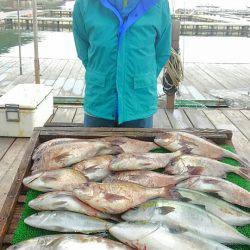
[165,155,250,180]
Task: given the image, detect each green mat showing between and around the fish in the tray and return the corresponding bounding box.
[12,145,250,250]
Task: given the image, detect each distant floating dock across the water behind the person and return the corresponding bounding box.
[0,10,250,37]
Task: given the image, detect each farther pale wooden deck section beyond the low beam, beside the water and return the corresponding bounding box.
[0,57,250,100]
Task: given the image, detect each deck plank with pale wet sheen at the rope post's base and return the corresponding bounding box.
[166,109,193,129]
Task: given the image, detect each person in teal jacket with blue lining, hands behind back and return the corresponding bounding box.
[73,0,172,128]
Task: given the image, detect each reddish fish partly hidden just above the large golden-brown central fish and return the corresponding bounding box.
[103,170,186,188]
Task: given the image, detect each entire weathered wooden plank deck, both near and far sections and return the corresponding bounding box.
[0,57,250,224]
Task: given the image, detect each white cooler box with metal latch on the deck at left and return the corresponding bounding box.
[0,84,53,137]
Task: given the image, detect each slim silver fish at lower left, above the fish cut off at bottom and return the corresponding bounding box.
[24,211,113,234]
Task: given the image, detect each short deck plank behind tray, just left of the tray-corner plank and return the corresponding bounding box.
[184,109,215,129]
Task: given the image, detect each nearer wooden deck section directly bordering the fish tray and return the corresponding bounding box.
[0,107,250,216]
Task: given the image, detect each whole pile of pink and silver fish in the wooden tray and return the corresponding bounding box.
[9,132,250,250]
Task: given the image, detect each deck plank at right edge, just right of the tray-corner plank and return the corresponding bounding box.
[222,109,250,140]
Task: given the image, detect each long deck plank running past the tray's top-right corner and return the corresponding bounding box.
[203,109,250,159]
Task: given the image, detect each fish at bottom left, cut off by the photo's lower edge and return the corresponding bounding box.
[7,234,131,250]
